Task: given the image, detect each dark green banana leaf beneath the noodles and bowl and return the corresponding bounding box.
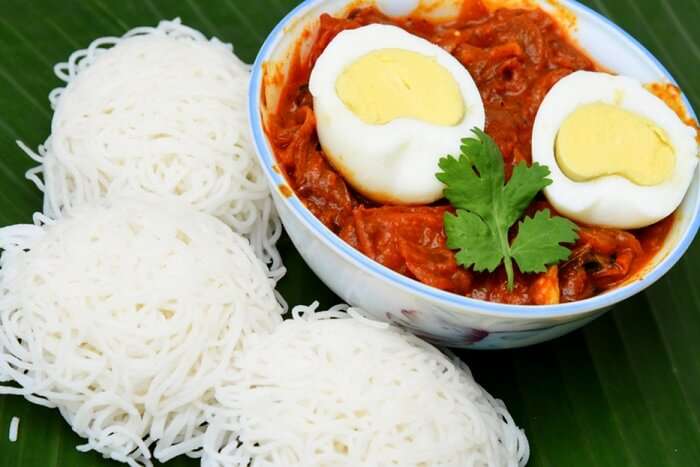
[0,0,700,467]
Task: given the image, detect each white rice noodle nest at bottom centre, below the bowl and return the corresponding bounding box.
[202,304,529,467]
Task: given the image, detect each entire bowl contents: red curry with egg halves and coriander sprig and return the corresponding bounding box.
[266,0,698,305]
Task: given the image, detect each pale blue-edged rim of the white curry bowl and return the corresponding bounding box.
[248,0,700,319]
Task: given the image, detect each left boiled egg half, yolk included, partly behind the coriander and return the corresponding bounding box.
[309,24,485,204]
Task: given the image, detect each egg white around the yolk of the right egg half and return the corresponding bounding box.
[532,71,698,229]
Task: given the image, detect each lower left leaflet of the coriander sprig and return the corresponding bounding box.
[445,209,503,272]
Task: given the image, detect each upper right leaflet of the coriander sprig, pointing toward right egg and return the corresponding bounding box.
[503,162,552,225]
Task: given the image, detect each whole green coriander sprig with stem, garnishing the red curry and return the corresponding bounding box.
[437,129,578,290]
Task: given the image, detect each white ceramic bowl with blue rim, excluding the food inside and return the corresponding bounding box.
[249,0,700,349]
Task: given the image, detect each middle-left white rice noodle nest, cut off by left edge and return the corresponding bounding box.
[0,196,283,466]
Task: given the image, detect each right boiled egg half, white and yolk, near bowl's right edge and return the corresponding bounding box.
[532,71,698,229]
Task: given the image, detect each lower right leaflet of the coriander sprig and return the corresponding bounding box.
[510,209,578,272]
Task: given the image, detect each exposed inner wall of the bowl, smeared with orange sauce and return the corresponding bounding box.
[252,0,700,311]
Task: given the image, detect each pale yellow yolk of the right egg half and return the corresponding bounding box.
[555,102,676,186]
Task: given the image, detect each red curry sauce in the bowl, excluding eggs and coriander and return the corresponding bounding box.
[267,1,673,304]
